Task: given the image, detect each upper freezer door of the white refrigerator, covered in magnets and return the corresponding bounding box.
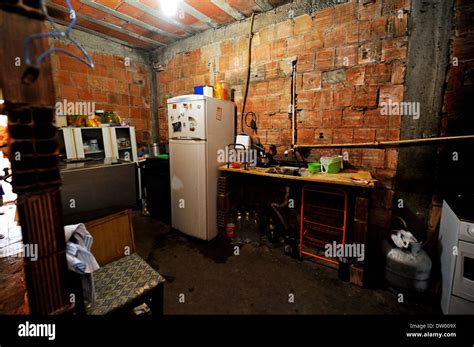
[168,95,206,140]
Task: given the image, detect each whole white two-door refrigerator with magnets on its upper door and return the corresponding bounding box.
[168,95,234,240]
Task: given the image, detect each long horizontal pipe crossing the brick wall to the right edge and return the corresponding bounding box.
[295,135,474,149]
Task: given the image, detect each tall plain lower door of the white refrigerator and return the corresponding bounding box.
[169,139,209,240]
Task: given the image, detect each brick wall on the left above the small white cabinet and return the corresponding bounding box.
[51,41,151,142]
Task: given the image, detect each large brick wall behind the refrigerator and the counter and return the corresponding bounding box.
[158,0,410,237]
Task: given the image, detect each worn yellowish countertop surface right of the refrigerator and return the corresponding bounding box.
[219,164,374,188]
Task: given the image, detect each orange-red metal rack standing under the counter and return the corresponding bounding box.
[299,186,347,265]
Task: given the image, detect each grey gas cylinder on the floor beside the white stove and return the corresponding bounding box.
[384,230,432,293]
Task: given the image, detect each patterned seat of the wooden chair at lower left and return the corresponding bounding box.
[87,253,165,315]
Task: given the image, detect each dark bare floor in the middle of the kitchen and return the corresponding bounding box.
[133,211,439,314]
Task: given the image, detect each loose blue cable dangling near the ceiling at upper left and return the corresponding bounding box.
[22,0,94,84]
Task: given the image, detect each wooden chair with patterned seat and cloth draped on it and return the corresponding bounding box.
[71,210,165,315]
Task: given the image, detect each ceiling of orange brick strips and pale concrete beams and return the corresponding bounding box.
[47,0,291,50]
